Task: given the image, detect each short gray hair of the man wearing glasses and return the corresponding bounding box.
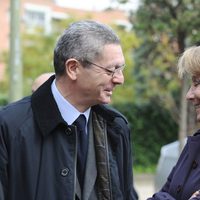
[54,20,120,75]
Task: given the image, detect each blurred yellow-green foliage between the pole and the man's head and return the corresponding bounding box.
[22,19,72,95]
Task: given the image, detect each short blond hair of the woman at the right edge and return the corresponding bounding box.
[177,46,200,78]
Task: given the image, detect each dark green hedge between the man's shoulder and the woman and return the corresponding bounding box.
[113,100,178,170]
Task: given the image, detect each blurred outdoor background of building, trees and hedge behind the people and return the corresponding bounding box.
[0,0,200,199]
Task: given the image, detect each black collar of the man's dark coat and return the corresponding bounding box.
[31,75,127,136]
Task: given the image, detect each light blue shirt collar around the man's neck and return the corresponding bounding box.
[51,79,91,125]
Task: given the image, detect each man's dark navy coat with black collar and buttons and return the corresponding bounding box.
[0,78,137,200]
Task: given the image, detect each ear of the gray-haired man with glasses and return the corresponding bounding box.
[65,58,79,80]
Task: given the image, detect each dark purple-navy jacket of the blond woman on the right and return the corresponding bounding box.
[148,131,200,200]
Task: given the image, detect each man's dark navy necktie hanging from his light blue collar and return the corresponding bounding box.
[74,114,88,189]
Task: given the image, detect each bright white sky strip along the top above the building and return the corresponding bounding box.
[56,0,139,11]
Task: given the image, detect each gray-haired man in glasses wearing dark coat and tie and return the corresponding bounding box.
[0,21,137,200]
